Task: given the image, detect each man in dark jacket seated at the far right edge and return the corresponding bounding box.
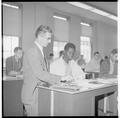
[100,49,118,77]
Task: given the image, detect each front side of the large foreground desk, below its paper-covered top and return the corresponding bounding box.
[38,78,117,116]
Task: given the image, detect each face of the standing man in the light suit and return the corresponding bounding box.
[38,32,52,47]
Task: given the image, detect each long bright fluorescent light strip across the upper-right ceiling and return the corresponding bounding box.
[67,2,117,21]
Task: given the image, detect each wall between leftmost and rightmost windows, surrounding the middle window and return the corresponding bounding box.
[23,3,80,59]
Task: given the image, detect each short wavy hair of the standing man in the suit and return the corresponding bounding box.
[35,25,52,38]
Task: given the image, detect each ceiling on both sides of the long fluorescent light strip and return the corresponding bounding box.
[41,2,117,26]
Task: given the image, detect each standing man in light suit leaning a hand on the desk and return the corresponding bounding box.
[21,25,61,116]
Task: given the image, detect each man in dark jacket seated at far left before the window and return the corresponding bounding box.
[6,47,23,76]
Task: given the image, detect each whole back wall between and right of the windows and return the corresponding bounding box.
[23,3,117,57]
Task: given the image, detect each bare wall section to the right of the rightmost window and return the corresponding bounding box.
[96,22,117,56]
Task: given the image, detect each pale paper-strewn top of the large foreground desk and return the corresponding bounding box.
[38,78,117,94]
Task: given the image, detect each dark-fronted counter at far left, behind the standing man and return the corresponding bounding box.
[2,76,23,116]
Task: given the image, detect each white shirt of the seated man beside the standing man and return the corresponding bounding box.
[50,57,85,79]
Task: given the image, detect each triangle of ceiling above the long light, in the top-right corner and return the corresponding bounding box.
[83,2,117,16]
